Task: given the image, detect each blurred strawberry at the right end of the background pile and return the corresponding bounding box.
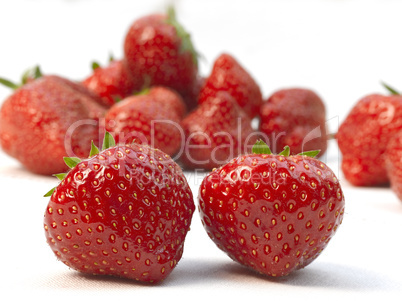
[260,88,327,155]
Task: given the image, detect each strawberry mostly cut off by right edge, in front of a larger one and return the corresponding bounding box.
[384,132,402,201]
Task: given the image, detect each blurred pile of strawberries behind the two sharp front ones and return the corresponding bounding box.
[0,10,327,175]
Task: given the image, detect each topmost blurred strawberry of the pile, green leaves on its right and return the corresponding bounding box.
[124,9,198,108]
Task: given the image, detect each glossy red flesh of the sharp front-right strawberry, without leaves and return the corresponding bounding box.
[198,154,345,276]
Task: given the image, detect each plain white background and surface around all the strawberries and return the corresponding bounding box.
[0,0,402,300]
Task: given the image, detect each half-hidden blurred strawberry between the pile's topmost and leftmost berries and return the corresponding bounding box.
[82,60,141,107]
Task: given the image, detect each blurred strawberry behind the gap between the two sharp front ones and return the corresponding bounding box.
[181,92,257,169]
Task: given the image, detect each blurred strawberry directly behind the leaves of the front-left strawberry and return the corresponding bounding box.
[105,87,186,155]
